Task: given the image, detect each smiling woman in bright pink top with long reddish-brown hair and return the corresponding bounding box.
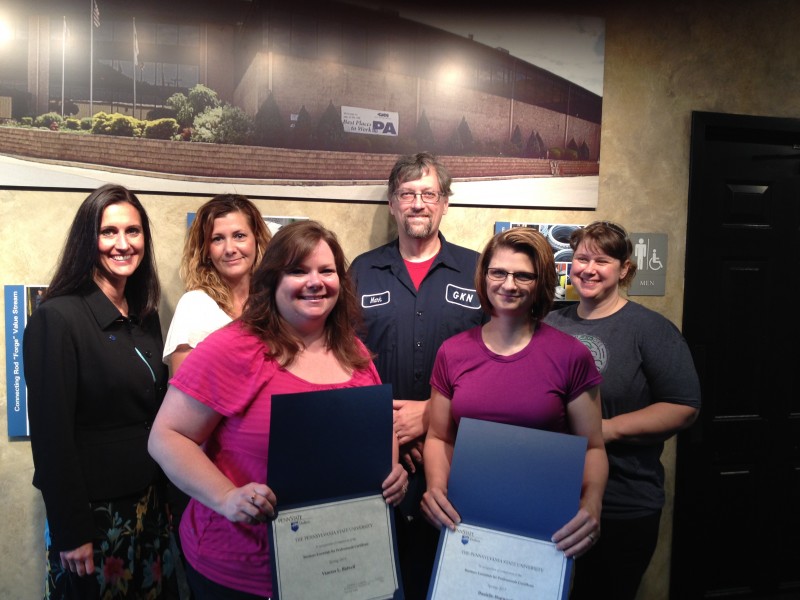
[149,221,407,600]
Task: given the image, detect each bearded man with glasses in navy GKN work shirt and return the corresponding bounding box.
[350,152,484,600]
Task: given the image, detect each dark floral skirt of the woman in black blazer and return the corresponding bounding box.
[44,485,178,600]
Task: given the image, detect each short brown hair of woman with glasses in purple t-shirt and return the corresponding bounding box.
[475,227,558,323]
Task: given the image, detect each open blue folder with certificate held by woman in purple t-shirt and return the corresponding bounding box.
[428,418,587,600]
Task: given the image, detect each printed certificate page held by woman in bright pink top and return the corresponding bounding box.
[271,495,399,600]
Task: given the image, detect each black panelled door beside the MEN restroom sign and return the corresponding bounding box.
[671,112,800,600]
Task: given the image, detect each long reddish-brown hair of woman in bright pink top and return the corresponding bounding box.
[240,221,371,370]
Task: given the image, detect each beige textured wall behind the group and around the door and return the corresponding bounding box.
[0,0,800,600]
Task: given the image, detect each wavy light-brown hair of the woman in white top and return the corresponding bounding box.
[180,194,272,316]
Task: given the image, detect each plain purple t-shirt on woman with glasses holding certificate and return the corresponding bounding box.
[431,323,602,433]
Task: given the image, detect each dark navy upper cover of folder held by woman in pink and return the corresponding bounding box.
[267,384,394,509]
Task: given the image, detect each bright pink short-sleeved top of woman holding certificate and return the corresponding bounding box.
[170,322,381,596]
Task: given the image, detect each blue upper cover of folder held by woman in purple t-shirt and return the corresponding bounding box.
[447,418,587,541]
